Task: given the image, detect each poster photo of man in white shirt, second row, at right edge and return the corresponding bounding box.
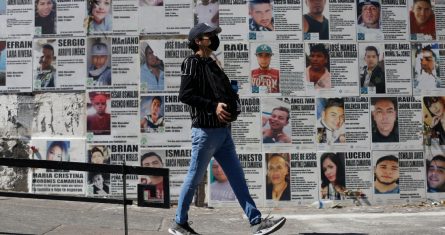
[411,42,445,95]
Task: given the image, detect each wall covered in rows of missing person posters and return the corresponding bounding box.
[0,0,445,206]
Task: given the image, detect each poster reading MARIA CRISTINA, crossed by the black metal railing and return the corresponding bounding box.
[28,137,86,195]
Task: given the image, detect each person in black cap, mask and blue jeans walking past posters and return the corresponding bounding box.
[168,23,286,235]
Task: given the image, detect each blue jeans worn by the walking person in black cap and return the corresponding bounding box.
[175,127,261,224]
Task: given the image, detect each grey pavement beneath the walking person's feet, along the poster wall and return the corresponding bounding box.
[0,197,445,235]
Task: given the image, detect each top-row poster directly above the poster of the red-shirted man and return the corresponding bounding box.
[244,0,302,41]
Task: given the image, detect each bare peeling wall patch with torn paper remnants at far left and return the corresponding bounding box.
[0,93,85,191]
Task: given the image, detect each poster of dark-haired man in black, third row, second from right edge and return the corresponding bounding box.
[371,96,422,150]
